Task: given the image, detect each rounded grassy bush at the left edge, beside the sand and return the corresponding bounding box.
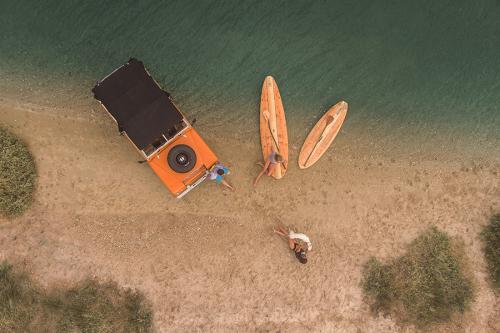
[0,127,36,217]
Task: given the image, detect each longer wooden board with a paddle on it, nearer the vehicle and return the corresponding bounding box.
[260,76,288,179]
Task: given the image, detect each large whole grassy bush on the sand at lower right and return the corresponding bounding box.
[362,227,473,327]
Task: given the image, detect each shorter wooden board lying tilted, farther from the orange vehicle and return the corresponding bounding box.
[299,101,348,169]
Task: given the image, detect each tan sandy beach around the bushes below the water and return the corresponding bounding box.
[0,99,500,332]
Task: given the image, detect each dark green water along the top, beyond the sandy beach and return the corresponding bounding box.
[0,0,500,154]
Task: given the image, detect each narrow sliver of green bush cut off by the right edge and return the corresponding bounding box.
[481,214,500,291]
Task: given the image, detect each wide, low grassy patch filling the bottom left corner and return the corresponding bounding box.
[0,262,153,333]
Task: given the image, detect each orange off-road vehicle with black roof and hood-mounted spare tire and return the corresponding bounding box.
[92,58,217,198]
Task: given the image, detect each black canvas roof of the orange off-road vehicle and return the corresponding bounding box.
[92,58,183,149]
